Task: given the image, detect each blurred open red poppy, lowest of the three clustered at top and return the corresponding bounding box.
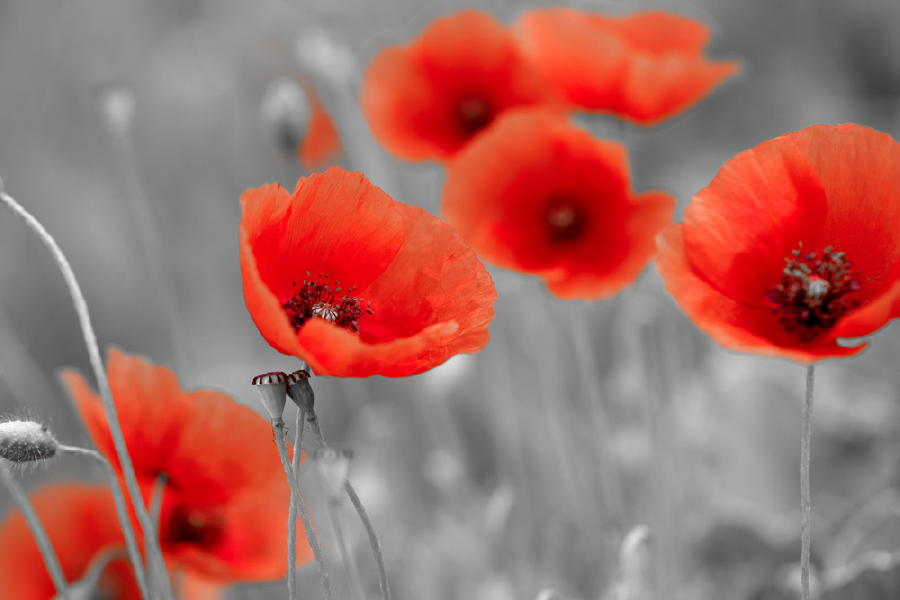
[441,110,675,300]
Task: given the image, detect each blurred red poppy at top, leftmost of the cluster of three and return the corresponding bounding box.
[360,10,558,160]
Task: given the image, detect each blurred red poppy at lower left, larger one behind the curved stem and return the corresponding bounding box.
[62,349,312,584]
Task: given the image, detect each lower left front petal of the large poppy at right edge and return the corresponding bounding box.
[656,223,866,363]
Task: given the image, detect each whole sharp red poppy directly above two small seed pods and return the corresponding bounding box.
[240,167,497,377]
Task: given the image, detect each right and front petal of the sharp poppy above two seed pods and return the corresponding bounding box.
[299,203,497,377]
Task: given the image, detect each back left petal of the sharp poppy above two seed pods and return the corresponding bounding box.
[241,167,404,358]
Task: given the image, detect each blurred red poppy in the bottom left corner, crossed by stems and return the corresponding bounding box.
[0,483,141,600]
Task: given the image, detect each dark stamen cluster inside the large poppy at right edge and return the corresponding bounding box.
[766,244,860,342]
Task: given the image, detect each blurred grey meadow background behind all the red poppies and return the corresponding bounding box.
[0,0,900,600]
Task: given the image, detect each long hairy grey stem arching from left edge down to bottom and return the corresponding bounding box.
[0,182,174,599]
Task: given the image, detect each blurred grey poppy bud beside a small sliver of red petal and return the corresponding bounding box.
[260,77,312,156]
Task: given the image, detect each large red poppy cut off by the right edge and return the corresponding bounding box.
[657,124,900,363]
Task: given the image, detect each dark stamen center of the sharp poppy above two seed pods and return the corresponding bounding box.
[281,272,374,334]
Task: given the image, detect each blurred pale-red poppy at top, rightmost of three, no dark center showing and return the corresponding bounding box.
[515,8,738,125]
